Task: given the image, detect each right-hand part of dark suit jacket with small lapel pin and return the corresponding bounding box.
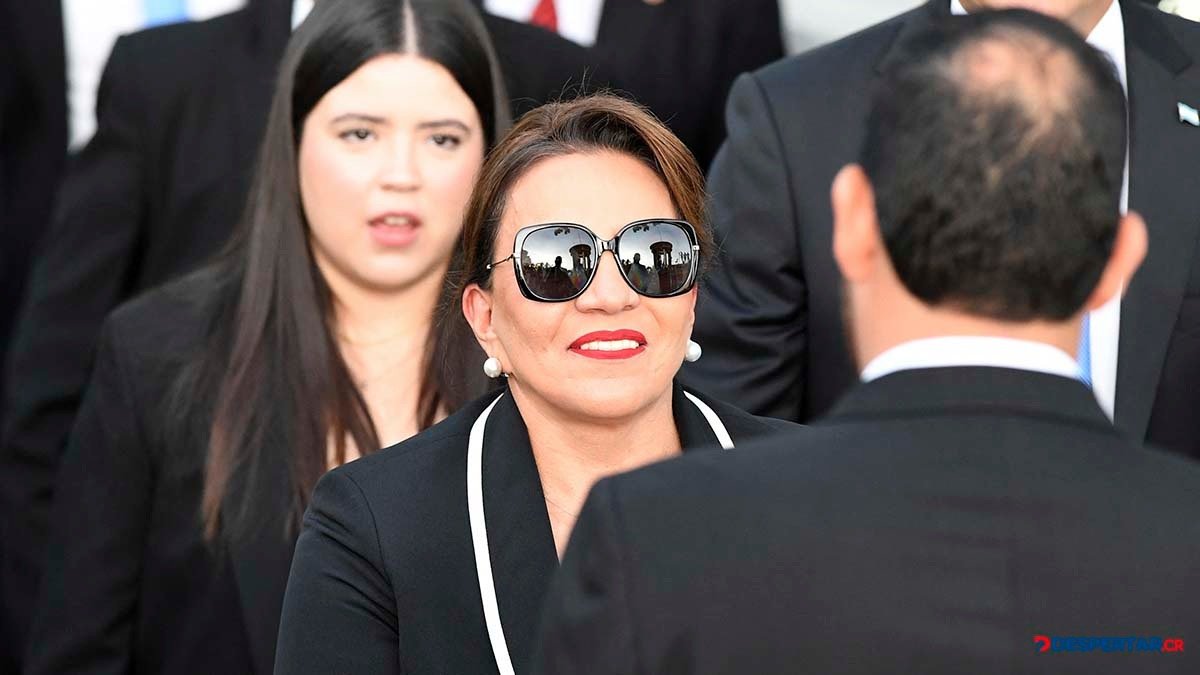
[1115,1,1200,438]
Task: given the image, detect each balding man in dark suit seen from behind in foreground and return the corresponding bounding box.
[540,11,1200,675]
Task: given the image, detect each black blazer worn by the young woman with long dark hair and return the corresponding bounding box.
[24,276,294,675]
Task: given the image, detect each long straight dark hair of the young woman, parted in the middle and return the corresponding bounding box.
[175,0,510,542]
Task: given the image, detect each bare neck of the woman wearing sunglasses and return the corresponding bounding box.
[511,382,682,515]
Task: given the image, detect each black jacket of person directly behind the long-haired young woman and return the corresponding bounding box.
[0,0,604,653]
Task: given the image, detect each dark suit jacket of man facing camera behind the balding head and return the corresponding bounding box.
[680,0,1200,458]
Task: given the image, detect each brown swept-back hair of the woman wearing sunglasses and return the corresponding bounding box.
[443,94,713,307]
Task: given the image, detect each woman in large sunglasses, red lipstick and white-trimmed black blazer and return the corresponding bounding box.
[277,96,793,674]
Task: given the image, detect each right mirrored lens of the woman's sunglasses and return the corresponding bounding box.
[617,221,695,298]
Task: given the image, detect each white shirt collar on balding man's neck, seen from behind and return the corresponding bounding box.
[862,336,1079,382]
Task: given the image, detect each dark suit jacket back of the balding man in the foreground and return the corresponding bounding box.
[533,368,1200,675]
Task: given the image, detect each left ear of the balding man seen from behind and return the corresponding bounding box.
[830,165,883,283]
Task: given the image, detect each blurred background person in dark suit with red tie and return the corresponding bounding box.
[475,0,784,169]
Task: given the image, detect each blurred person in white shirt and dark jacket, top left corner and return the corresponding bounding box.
[0,0,245,396]
